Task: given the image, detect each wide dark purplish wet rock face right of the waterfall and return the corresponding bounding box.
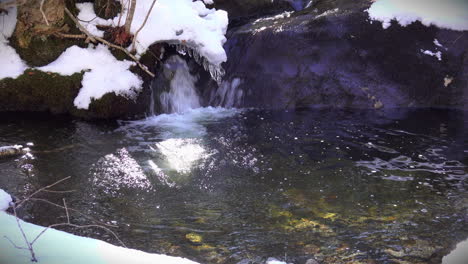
[225,0,468,109]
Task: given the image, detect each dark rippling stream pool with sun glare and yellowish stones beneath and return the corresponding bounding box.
[0,109,468,264]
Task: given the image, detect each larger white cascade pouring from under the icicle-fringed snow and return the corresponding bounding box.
[159,55,201,113]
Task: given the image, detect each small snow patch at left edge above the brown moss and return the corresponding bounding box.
[0,7,27,80]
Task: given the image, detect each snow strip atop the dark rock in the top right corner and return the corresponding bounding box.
[368,0,468,31]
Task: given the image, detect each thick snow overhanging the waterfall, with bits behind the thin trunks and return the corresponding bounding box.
[77,0,228,66]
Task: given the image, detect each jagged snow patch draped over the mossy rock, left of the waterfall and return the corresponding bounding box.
[38,44,143,109]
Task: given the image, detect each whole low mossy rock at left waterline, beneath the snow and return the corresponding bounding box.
[0,69,148,119]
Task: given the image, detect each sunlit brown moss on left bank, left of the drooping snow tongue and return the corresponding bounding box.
[0,69,83,113]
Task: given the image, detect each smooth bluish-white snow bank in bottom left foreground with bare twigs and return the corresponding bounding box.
[0,189,196,264]
